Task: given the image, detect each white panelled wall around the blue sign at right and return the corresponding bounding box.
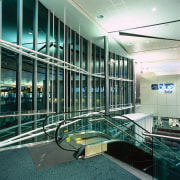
[136,75,180,117]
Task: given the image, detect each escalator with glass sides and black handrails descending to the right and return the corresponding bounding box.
[44,112,180,179]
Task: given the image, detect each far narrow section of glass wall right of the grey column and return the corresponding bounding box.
[109,52,133,114]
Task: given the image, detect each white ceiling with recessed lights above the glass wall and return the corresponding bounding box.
[40,0,180,74]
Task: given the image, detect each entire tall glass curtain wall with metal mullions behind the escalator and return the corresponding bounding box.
[0,0,133,142]
